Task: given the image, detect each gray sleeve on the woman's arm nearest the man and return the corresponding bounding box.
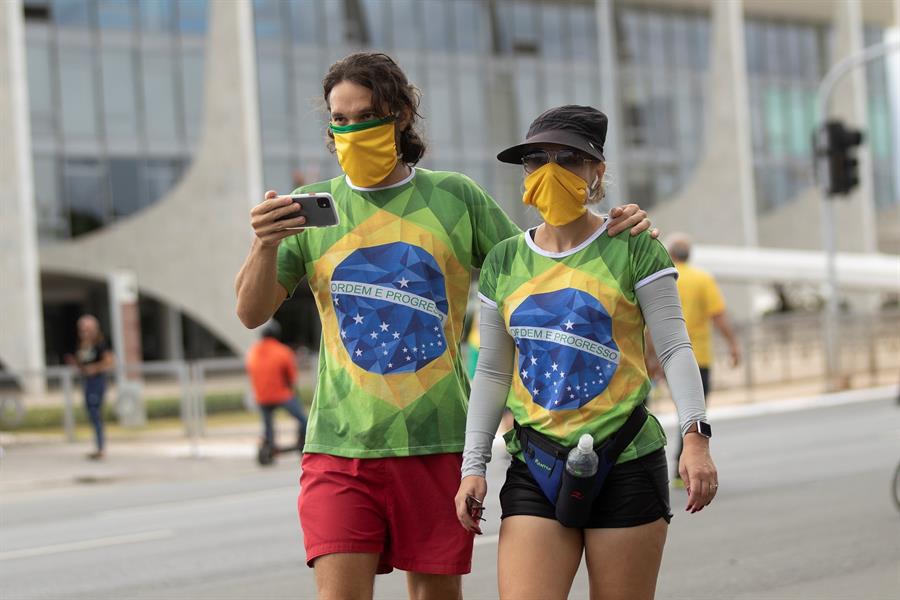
[462,301,516,477]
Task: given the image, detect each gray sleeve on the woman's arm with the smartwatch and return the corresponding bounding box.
[635,275,706,435]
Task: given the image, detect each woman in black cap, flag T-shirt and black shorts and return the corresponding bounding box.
[456,106,718,600]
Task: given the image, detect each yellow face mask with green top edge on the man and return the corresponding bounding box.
[328,117,399,187]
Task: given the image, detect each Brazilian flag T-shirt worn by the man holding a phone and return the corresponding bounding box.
[278,168,520,458]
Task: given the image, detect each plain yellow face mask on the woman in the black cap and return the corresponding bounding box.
[522,162,588,227]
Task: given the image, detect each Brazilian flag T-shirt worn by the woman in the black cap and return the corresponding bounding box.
[479,223,677,462]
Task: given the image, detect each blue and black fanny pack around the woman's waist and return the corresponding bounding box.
[515,403,647,506]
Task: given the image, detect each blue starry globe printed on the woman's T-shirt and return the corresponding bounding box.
[509,288,619,410]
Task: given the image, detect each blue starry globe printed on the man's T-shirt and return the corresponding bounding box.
[331,242,448,374]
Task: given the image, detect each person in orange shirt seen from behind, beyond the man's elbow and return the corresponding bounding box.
[247,319,306,448]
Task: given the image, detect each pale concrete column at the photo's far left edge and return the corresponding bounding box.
[0,0,44,394]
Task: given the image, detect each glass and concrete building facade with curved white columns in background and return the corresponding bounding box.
[0,0,900,380]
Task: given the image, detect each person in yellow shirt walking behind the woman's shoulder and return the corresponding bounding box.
[647,233,741,487]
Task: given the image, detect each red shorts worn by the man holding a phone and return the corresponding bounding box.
[297,454,474,575]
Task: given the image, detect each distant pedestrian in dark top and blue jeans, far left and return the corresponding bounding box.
[65,315,116,460]
